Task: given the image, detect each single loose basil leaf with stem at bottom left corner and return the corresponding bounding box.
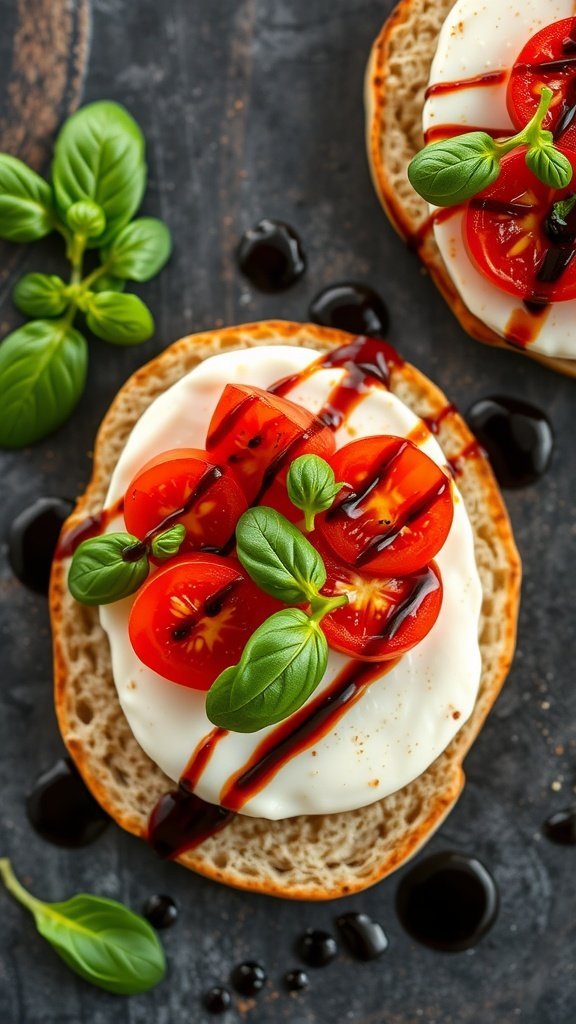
[0,858,166,995]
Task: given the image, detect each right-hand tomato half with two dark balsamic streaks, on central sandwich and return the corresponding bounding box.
[317,435,454,577]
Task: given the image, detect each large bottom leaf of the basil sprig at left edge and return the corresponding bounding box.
[0,319,88,447]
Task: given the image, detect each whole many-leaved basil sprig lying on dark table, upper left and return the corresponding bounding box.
[0,101,171,447]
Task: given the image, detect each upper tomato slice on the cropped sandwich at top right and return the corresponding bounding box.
[506,17,576,150]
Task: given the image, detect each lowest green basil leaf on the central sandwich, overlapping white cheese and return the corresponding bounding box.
[206,608,328,732]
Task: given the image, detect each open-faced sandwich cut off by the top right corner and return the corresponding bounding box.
[366,0,576,376]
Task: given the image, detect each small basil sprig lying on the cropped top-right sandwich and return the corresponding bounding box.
[408,87,572,206]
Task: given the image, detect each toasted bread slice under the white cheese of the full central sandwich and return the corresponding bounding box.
[50,322,521,899]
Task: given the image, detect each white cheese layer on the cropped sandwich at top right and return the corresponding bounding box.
[422,0,576,358]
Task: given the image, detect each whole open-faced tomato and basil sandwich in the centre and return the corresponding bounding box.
[51,322,520,899]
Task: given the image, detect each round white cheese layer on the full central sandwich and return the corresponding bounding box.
[100,346,482,818]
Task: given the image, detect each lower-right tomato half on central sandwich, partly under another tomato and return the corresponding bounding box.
[318,542,442,662]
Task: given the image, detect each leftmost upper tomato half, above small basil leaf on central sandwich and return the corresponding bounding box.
[124,449,247,551]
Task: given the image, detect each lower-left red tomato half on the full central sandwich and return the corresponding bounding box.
[128,554,282,690]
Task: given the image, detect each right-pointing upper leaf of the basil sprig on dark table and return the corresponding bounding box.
[101,217,172,281]
